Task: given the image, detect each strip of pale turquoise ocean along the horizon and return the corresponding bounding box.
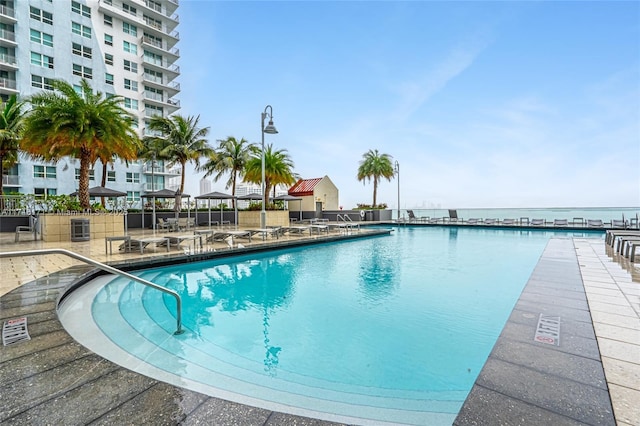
[393,207,640,222]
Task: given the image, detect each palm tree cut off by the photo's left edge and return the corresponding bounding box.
[0,95,25,198]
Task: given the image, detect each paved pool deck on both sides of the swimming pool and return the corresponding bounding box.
[0,228,640,425]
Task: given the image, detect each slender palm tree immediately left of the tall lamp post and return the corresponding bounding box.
[200,136,255,207]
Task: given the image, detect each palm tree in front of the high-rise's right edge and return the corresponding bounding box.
[145,115,213,194]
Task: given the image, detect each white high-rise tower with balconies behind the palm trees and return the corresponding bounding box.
[0,0,181,208]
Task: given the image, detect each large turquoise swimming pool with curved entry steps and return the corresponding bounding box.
[61,227,596,424]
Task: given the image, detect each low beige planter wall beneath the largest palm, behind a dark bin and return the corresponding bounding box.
[40,214,124,242]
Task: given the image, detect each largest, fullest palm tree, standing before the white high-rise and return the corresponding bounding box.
[20,79,140,209]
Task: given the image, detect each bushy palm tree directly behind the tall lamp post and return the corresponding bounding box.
[244,144,298,206]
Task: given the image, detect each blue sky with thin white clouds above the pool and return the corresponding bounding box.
[172,0,640,209]
